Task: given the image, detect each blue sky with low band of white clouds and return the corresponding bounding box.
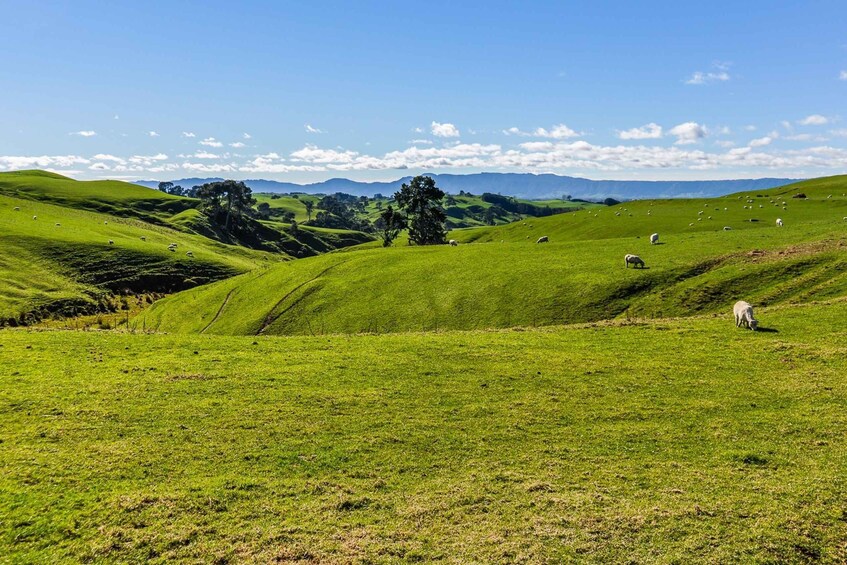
[0,0,847,182]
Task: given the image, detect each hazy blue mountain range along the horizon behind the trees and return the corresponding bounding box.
[136,173,802,200]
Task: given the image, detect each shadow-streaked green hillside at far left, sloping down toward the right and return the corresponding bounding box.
[0,195,270,319]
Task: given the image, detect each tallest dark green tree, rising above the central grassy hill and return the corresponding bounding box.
[394,176,447,245]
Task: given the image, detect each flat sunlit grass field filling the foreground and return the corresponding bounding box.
[0,300,847,563]
